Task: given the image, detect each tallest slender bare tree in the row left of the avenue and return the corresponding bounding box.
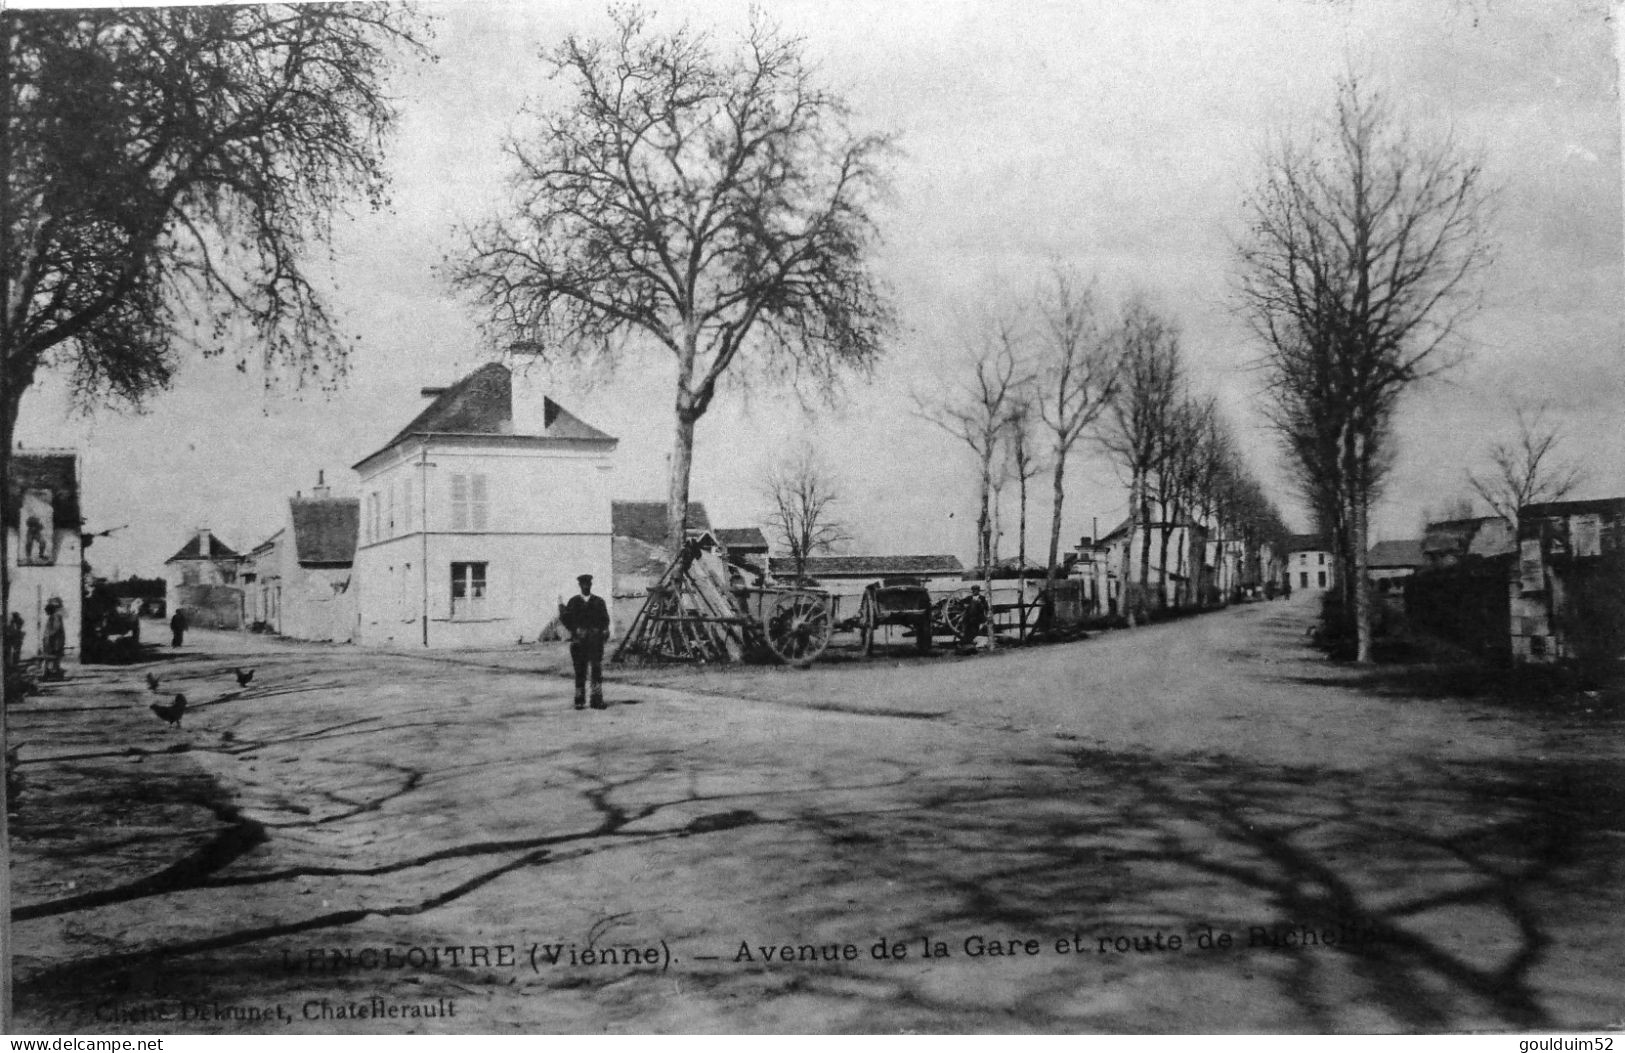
[1035,268,1121,588]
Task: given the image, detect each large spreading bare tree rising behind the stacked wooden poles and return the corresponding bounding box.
[453,8,892,546]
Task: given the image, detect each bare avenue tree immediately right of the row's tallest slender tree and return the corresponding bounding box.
[1099,301,1185,626]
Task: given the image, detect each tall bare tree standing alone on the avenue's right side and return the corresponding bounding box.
[1240,76,1490,661]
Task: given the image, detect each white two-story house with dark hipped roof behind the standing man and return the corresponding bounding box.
[353,362,616,648]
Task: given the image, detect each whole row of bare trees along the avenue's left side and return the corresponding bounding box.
[915,267,1285,624]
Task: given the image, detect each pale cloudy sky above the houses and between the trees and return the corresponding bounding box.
[18,0,1625,575]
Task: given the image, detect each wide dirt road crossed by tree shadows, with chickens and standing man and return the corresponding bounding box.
[13,603,1625,1034]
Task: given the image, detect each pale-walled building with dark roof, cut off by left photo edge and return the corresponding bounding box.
[5,450,83,655]
